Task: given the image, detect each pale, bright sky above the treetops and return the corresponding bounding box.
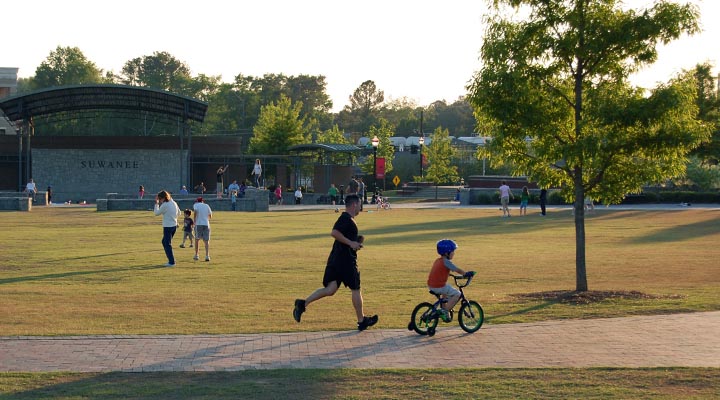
[0,0,720,111]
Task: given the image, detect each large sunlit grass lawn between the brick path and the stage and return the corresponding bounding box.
[0,207,720,335]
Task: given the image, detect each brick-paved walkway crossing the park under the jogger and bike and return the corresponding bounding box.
[0,312,720,372]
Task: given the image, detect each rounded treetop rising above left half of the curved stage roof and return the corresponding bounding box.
[32,46,103,89]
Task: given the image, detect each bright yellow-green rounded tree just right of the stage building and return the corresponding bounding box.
[250,96,309,154]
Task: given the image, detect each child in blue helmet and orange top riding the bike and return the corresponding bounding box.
[427,239,474,322]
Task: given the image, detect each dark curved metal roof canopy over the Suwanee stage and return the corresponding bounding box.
[0,85,208,122]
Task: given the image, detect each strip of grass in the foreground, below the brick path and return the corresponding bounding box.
[0,368,720,400]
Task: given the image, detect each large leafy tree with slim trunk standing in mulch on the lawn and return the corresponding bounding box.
[470,0,708,291]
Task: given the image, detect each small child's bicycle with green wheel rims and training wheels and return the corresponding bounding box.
[408,272,485,336]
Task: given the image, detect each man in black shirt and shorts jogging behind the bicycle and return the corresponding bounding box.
[293,195,378,331]
